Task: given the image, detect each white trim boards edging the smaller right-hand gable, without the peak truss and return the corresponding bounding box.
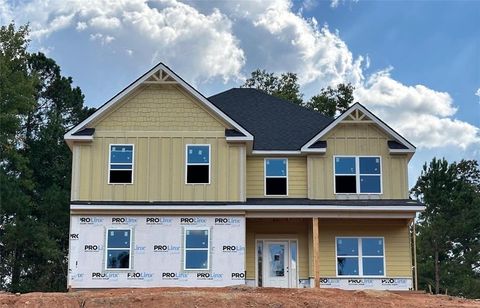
[301,103,415,153]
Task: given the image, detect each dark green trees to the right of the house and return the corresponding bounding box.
[411,158,480,298]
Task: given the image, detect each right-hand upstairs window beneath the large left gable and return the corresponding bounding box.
[186,144,210,184]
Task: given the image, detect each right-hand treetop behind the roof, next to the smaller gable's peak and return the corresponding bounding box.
[306,83,355,117]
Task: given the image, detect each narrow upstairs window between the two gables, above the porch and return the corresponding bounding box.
[265,158,288,196]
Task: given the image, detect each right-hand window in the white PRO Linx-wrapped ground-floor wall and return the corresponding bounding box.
[184,229,210,270]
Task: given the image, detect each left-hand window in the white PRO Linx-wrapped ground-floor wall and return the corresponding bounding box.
[105,229,131,269]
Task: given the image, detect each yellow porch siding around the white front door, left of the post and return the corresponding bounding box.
[245,219,309,279]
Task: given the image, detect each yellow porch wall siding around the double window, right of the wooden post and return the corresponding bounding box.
[319,219,412,278]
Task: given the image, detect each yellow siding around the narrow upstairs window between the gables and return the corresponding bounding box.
[247,156,307,198]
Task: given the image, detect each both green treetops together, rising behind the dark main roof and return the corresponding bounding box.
[242,69,355,117]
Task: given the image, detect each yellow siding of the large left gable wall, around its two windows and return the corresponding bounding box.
[72,85,245,201]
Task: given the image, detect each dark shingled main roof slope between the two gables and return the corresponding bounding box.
[208,88,333,151]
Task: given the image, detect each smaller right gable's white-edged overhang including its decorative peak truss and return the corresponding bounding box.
[301,103,415,153]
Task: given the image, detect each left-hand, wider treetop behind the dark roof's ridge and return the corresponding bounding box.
[242,69,303,105]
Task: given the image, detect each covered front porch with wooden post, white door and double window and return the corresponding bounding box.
[245,217,414,290]
